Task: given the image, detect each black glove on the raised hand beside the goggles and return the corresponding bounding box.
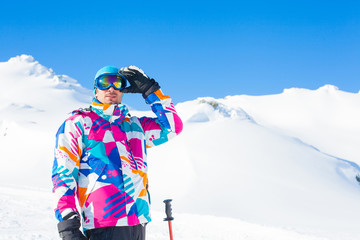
[119,66,160,98]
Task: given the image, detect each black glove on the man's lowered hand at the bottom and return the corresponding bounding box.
[58,216,87,240]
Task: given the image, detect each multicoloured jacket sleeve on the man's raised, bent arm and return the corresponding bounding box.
[140,89,183,147]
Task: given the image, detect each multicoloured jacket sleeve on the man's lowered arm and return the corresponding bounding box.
[52,117,82,221]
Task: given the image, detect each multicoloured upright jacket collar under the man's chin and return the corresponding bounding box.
[91,98,129,122]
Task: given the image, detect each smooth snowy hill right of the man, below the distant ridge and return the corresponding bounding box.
[150,99,360,239]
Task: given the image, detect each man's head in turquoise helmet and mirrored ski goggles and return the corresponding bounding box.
[94,66,126,104]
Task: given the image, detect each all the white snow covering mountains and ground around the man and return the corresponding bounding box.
[0,55,360,240]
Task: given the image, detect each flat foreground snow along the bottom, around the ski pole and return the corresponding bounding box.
[0,186,326,240]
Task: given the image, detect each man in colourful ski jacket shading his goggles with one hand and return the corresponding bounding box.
[52,66,182,240]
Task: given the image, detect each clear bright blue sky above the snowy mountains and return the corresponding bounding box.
[0,0,360,109]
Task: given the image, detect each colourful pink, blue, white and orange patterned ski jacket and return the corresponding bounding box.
[52,90,183,230]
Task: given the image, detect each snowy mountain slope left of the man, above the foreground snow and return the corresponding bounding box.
[0,55,91,187]
